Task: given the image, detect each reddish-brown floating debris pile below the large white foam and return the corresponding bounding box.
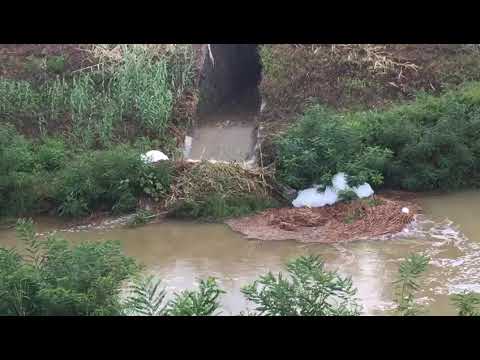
[227,196,420,243]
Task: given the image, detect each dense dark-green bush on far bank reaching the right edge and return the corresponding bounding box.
[359,83,480,190]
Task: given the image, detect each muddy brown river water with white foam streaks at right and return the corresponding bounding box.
[0,192,480,315]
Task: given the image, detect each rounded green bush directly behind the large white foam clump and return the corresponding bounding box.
[276,106,391,189]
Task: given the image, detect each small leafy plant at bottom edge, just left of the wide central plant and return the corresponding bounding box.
[166,278,225,316]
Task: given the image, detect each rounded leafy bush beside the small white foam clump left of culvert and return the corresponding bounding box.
[53,146,171,217]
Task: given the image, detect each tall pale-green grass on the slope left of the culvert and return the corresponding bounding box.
[0,45,194,148]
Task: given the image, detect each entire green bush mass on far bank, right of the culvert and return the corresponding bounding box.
[276,83,480,191]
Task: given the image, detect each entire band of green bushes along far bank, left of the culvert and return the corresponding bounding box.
[0,125,173,217]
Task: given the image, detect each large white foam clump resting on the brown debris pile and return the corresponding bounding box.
[292,173,374,208]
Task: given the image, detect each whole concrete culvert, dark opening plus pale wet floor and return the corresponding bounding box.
[185,44,262,164]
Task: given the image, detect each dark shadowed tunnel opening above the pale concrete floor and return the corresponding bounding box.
[198,44,262,116]
